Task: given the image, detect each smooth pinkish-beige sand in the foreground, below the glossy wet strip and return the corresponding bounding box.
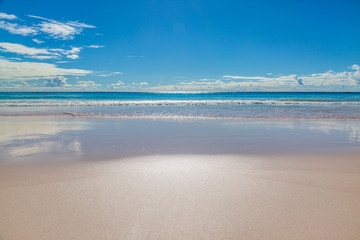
[0,154,360,240]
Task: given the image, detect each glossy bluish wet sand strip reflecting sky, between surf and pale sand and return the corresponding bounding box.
[0,117,360,163]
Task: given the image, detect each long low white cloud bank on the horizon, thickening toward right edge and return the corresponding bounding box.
[149,64,360,92]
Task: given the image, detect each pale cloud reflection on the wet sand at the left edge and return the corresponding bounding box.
[0,118,89,162]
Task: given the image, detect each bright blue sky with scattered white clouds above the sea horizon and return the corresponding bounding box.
[0,0,360,92]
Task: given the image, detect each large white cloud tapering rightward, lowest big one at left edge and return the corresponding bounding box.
[0,58,92,81]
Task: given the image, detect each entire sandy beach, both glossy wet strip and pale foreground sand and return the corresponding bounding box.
[0,118,360,239]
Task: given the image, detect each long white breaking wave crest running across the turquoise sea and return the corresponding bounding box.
[0,99,360,107]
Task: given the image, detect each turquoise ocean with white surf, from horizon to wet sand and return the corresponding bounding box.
[0,92,360,119]
